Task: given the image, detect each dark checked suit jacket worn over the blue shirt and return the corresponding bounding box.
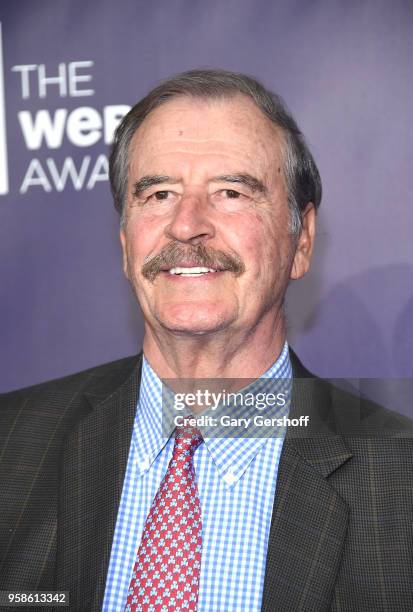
[0,354,413,612]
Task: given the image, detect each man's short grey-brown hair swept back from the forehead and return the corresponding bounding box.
[109,70,322,236]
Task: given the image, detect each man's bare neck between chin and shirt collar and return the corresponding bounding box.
[143,315,285,379]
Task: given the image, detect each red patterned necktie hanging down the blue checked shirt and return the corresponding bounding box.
[125,428,202,612]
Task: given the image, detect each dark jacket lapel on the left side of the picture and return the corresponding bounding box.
[57,360,141,610]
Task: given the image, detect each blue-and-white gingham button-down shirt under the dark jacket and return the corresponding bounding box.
[102,343,292,612]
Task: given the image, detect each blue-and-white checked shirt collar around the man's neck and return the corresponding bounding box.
[132,342,292,487]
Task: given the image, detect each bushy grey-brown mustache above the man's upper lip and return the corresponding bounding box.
[142,243,245,282]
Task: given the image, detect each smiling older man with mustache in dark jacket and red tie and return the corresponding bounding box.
[0,70,413,612]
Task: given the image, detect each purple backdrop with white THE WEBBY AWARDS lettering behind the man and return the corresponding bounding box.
[0,0,413,400]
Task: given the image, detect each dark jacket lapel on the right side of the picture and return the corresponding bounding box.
[262,355,351,612]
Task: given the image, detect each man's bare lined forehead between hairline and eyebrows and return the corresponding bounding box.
[130,98,284,191]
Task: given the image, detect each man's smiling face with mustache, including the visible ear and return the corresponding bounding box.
[121,95,313,335]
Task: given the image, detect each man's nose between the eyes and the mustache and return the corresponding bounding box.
[165,195,215,245]
